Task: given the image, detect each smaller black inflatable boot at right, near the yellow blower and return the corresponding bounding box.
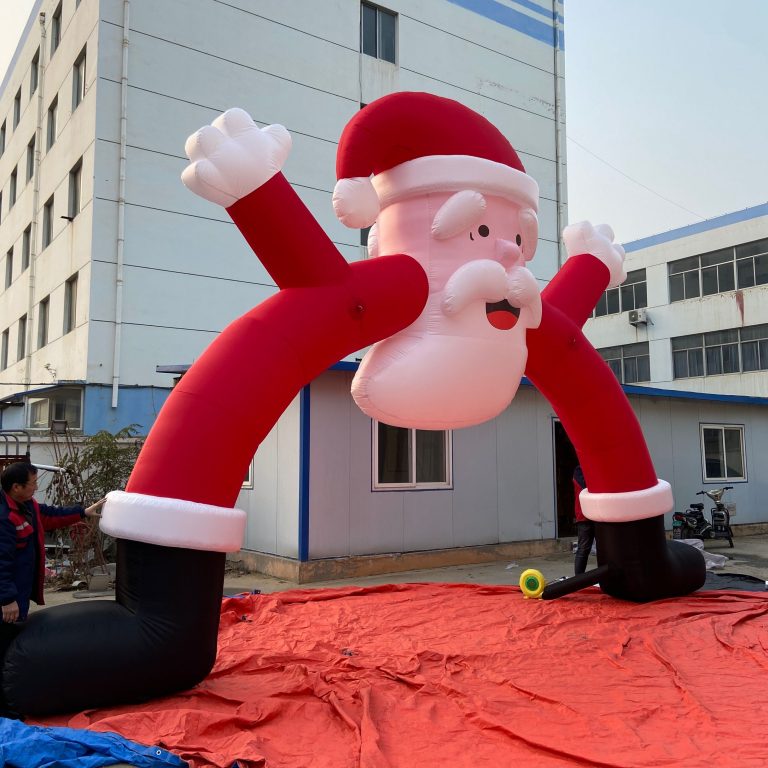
[595,515,707,603]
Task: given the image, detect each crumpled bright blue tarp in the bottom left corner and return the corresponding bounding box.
[0,717,187,768]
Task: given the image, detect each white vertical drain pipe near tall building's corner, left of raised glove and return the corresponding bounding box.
[112,0,131,408]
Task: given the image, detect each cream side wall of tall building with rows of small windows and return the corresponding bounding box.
[0,0,98,395]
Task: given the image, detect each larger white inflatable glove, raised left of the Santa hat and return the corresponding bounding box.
[181,107,291,208]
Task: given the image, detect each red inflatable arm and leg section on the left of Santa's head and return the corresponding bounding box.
[127,174,428,506]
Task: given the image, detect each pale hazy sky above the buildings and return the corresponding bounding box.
[0,0,768,242]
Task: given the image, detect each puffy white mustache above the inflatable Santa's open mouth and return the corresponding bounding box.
[442,259,541,328]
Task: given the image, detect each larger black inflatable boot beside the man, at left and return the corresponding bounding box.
[2,540,225,715]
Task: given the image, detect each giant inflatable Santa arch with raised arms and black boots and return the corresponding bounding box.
[3,93,705,714]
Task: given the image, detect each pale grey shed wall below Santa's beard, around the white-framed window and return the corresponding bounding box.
[309,371,556,559]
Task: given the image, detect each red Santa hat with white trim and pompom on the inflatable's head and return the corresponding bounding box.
[333,92,539,228]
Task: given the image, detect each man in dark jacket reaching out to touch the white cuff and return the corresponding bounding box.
[0,462,104,716]
